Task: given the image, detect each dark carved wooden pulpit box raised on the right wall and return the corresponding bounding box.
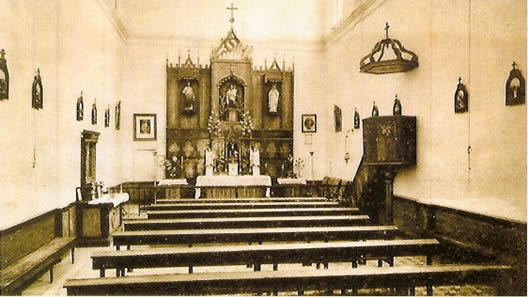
[363,116,416,167]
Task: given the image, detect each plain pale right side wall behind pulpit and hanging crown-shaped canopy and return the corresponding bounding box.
[326,0,527,220]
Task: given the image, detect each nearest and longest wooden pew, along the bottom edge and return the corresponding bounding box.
[64,265,511,295]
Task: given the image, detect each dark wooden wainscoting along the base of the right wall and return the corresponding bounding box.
[393,196,526,296]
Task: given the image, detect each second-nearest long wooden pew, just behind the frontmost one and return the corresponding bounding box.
[92,239,439,277]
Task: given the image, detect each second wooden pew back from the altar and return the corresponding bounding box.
[142,201,339,210]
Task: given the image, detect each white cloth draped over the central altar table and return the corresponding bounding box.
[194,175,271,199]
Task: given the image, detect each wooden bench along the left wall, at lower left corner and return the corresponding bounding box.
[0,237,75,295]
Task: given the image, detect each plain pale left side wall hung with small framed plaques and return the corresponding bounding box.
[0,0,123,229]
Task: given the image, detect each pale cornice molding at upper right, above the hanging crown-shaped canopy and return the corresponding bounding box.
[323,0,386,50]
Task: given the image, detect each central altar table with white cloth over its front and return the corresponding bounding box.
[195,175,271,199]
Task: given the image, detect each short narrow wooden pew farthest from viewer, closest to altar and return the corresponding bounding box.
[156,197,328,204]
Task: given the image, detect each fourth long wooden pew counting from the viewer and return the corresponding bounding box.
[123,215,369,231]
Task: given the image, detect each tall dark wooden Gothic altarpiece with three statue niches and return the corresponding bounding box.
[166,28,294,178]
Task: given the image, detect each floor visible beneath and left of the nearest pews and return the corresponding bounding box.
[23,242,495,296]
